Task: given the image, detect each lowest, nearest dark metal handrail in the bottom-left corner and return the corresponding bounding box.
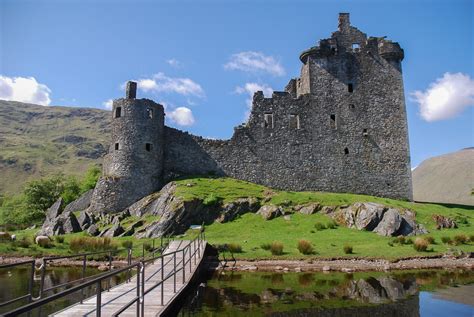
[3,262,142,317]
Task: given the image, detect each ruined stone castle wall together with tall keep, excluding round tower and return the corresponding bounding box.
[164,14,412,199]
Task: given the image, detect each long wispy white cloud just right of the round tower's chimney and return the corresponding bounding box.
[131,73,205,97]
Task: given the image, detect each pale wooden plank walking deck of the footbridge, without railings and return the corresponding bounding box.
[53,241,205,317]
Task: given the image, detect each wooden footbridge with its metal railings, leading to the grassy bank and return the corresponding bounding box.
[0,230,206,317]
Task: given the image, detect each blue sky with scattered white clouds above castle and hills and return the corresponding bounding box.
[0,0,474,166]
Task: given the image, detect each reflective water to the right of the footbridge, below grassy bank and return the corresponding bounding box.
[179,270,474,317]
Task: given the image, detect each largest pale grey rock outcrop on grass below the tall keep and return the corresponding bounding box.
[330,202,428,236]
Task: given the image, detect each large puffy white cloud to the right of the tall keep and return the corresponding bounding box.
[411,73,474,122]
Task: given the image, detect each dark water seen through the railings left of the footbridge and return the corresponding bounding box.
[0,266,126,316]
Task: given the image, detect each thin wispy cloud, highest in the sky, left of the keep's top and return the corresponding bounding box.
[224,51,285,76]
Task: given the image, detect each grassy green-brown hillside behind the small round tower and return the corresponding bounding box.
[0,100,110,194]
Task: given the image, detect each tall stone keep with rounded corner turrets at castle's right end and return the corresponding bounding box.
[287,13,412,200]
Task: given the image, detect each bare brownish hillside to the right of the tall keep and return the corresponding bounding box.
[412,148,474,205]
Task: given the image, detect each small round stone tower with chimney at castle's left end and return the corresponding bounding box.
[91,82,164,213]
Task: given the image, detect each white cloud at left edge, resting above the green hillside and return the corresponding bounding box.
[0,75,51,106]
